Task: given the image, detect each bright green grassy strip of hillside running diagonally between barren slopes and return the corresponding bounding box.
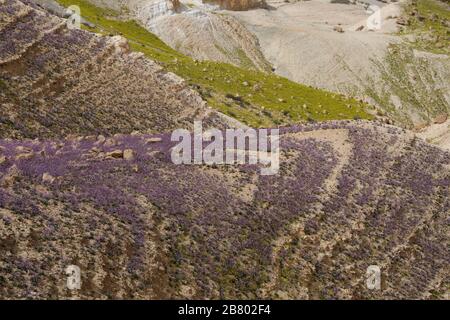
[58,0,372,127]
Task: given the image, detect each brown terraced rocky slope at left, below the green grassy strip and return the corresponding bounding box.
[0,0,230,138]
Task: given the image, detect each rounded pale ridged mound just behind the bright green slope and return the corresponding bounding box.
[148,6,270,70]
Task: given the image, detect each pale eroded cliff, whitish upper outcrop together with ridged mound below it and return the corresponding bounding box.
[88,0,271,71]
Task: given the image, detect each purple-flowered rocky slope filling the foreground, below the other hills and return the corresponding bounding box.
[0,122,450,299]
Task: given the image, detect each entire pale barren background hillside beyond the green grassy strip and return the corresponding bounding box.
[69,0,450,149]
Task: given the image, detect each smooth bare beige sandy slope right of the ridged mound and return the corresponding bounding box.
[229,0,398,93]
